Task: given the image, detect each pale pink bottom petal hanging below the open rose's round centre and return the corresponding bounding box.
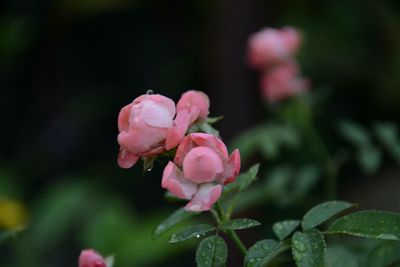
[185,183,222,211]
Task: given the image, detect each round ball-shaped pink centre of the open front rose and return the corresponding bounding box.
[183,147,224,184]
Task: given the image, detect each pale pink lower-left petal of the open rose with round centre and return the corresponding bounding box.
[161,161,197,199]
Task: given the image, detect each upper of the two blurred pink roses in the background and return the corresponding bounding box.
[247,27,301,68]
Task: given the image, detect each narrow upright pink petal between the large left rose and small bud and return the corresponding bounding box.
[165,110,190,150]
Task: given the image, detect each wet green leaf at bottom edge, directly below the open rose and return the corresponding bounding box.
[196,236,228,267]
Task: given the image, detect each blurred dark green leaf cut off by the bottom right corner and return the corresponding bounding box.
[368,241,400,267]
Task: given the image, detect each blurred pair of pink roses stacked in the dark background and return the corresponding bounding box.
[247,27,309,102]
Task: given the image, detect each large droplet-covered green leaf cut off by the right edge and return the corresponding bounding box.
[327,211,400,241]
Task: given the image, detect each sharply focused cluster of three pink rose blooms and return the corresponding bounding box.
[118,90,240,211]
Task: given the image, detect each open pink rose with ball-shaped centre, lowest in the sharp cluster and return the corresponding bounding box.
[161,133,240,211]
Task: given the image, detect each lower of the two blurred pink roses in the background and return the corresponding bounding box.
[261,61,310,102]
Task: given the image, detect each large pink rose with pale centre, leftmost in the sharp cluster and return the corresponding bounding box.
[118,94,190,168]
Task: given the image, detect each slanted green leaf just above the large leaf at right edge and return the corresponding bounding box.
[301,201,355,230]
